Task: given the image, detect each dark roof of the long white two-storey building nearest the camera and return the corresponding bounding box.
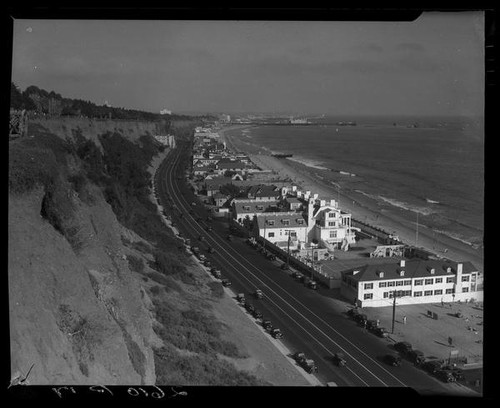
[343,259,477,282]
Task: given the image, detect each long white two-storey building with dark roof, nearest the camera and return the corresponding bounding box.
[340,259,483,307]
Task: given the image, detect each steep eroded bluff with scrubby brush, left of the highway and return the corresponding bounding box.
[8,121,261,385]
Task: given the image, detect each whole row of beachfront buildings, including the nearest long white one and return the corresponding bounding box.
[188,127,483,307]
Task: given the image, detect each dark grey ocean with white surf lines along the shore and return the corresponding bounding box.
[228,117,484,248]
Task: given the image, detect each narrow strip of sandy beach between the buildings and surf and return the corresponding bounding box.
[219,126,484,272]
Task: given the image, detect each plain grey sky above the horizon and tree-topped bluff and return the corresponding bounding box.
[12,11,484,116]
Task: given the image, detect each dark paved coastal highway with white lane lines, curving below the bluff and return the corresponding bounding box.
[155,144,464,394]
